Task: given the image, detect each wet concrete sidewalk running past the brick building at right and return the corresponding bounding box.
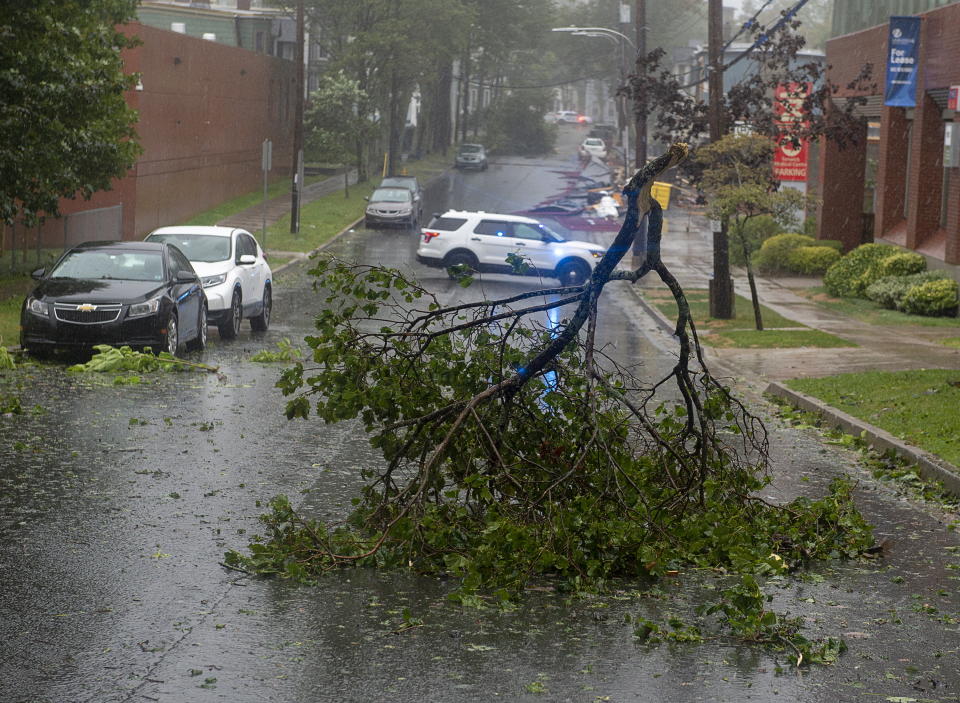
[636,201,960,381]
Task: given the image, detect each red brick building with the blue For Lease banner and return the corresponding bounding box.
[818,4,960,280]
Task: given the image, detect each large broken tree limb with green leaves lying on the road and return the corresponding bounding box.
[226,145,872,660]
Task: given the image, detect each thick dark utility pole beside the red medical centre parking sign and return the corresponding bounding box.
[707,0,734,320]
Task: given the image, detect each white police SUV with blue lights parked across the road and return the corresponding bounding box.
[417,210,605,286]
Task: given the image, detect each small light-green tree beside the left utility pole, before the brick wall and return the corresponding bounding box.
[304,71,376,197]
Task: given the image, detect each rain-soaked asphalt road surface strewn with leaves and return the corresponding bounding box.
[0,128,960,703]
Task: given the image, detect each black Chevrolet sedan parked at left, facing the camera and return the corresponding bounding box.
[20,242,207,354]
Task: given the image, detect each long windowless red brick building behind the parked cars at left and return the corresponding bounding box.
[30,23,296,248]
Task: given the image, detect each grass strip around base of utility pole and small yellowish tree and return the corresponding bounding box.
[643,288,856,349]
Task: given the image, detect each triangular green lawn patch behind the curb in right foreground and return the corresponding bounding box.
[785,369,960,465]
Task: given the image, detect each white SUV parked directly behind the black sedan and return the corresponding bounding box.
[147,227,273,339]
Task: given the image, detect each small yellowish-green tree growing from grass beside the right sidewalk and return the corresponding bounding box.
[696,134,808,330]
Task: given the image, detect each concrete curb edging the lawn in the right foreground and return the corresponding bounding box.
[765,382,960,496]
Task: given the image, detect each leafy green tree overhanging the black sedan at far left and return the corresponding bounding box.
[0,0,140,223]
